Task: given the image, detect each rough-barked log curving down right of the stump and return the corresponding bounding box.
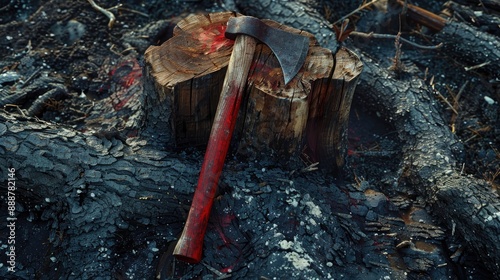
[356,53,500,275]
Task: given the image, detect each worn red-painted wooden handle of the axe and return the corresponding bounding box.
[173,35,256,263]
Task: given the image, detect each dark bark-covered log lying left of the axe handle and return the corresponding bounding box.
[0,113,196,279]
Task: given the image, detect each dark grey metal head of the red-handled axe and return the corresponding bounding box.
[225,16,309,85]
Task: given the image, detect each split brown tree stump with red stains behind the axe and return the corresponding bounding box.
[145,12,362,171]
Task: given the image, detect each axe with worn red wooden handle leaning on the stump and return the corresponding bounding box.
[173,16,309,263]
